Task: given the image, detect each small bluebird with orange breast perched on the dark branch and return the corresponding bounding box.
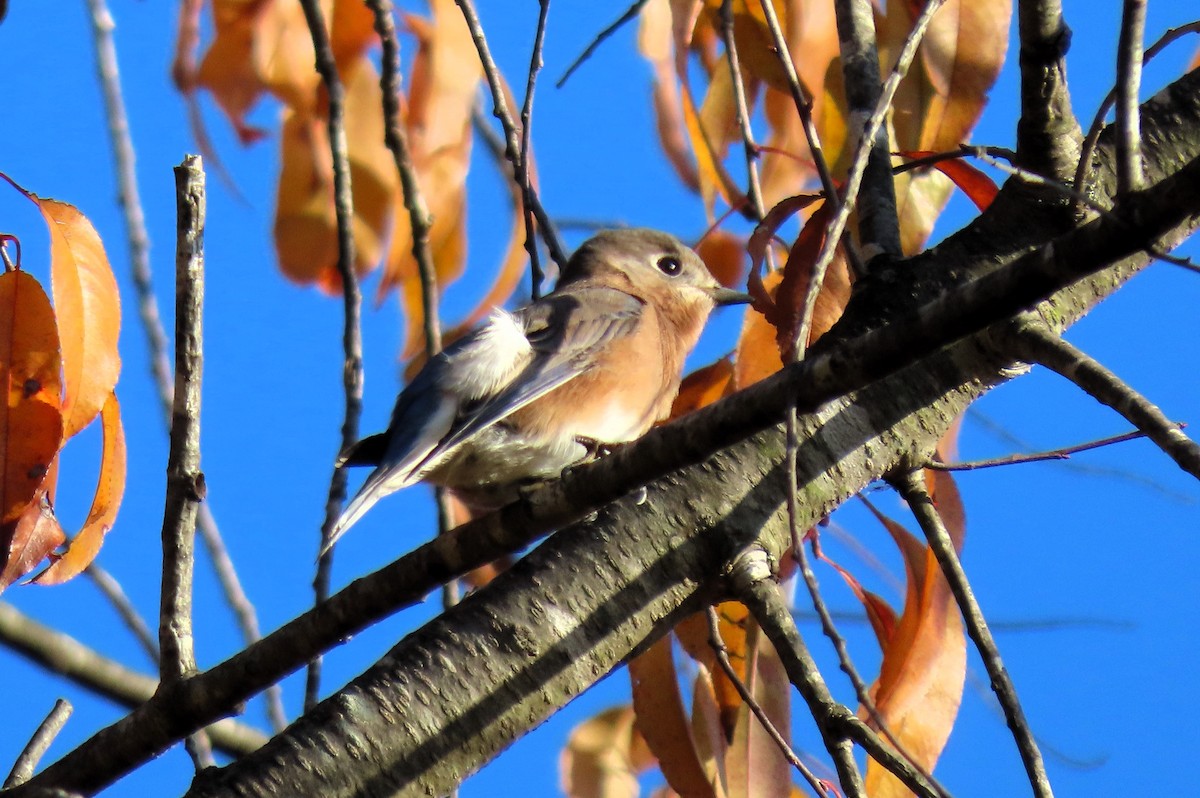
[329,229,750,546]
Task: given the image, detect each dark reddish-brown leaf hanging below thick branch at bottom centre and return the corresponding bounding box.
[629,637,716,797]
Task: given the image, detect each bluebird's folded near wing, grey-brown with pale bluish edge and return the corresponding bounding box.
[415,286,644,480]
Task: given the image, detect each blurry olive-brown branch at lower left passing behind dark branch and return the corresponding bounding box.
[0,601,266,756]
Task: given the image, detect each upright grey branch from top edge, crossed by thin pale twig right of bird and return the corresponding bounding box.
[833,0,901,257]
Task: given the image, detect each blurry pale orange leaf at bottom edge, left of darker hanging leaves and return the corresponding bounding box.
[558,706,654,798]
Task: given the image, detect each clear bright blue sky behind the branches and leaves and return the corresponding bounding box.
[0,0,1200,797]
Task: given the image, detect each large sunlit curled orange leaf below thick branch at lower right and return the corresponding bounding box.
[860,505,966,798]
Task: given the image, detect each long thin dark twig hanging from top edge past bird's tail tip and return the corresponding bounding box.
[300,0,362,712]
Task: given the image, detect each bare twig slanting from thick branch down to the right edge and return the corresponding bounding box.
[1012,319,1200,479]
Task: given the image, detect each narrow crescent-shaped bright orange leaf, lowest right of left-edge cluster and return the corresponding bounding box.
[32,394,125,584]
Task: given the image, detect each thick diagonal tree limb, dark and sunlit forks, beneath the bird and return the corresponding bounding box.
[13,66,1200,796]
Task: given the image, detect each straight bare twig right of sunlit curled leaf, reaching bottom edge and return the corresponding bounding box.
[893,470,1054,798]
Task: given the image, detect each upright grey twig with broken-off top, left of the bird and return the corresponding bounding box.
[158,155,212,770]
